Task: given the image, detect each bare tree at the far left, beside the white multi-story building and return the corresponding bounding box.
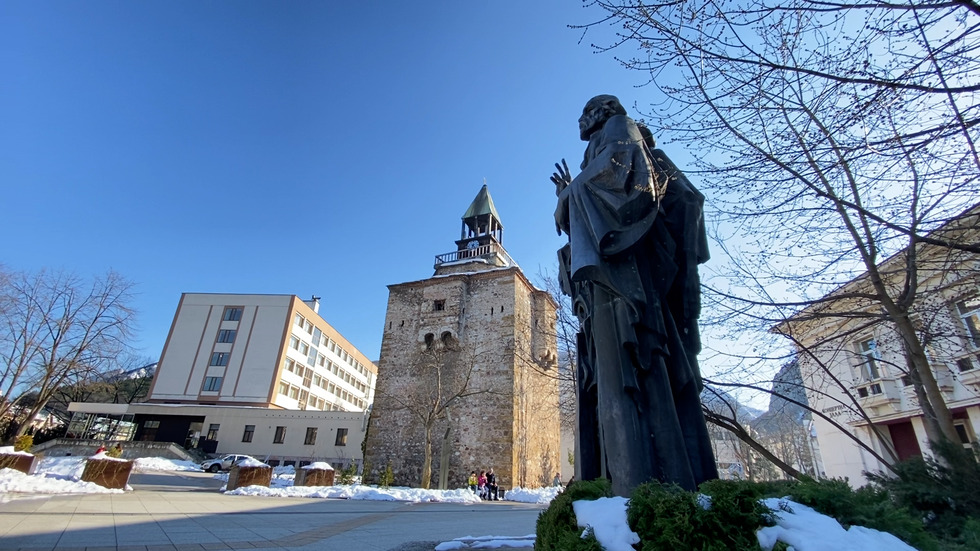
[0,271,134,435]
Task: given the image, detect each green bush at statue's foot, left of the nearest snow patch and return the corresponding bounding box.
[534,478,612,551]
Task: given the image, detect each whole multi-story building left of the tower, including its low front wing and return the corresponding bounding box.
[69,293,378,465]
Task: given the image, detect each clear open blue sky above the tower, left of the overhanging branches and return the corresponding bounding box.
[0,0,682,359]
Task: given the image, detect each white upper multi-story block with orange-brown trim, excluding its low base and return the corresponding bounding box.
[147,293,378,411]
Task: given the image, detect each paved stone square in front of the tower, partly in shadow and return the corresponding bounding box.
[0,473,543,551]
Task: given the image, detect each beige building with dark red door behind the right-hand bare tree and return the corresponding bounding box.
[777,208,980,485]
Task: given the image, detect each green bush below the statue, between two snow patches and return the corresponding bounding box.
[626,480,772,551]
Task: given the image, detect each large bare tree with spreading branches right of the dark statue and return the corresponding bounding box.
[584,0,980,448]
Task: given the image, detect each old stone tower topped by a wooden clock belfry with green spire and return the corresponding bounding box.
[365,185,560,488]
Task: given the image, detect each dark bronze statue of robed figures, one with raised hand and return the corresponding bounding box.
[551,95,718,496]
